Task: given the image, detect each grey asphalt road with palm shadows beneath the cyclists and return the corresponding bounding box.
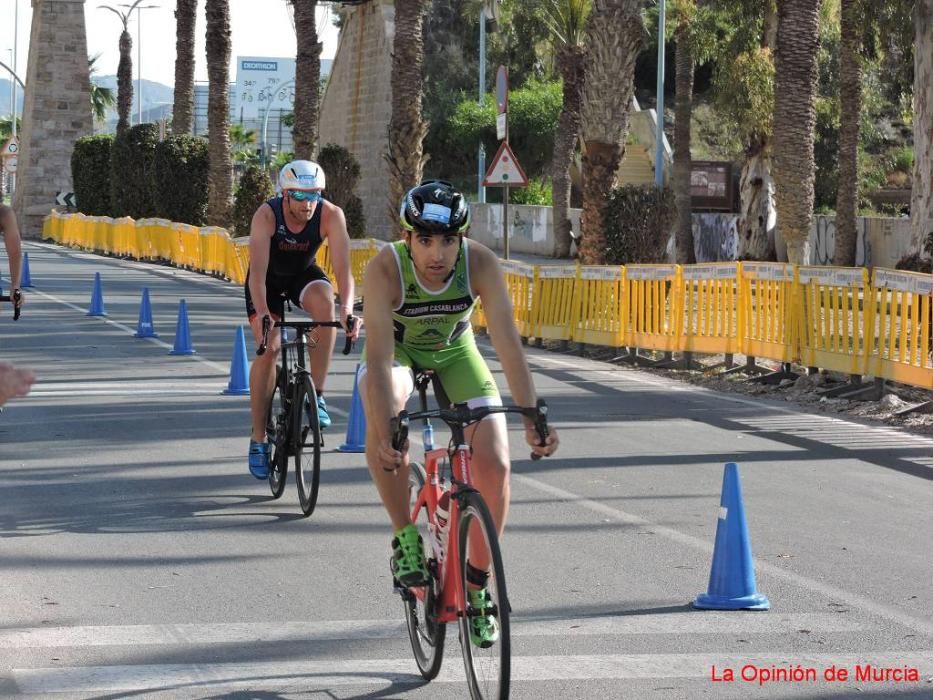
[0,243,933,700]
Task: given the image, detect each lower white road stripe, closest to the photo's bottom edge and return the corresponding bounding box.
[12,651,933,695]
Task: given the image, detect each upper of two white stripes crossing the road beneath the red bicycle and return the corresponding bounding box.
[0,610,864,649]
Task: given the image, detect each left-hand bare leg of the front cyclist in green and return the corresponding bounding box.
[359,367,413,530]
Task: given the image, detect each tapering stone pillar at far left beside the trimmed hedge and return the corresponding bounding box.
[13,0,93,238]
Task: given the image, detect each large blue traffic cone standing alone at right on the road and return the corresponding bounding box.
[693,462,771,610]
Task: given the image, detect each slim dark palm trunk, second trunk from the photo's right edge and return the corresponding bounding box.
[833,0,862,267]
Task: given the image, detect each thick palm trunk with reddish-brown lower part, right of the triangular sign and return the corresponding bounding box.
[580,0,645,263]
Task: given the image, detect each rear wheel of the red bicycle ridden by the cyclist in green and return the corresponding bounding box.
[402,462,447,680]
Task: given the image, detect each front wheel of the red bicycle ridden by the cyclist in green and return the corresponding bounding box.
[458,492,512,700]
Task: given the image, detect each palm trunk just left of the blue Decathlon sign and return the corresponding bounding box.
[206,0,233,226]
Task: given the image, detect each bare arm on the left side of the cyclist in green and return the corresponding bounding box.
[363,246,402,469]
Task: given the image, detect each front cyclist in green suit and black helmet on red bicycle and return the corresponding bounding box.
[358,180,559,646]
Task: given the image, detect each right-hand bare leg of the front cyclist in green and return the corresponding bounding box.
[465,416,511,570]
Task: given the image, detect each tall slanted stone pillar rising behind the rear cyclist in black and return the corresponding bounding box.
[319,0,395,239]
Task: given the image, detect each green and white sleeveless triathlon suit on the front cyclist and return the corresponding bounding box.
[364,239,500,405]
